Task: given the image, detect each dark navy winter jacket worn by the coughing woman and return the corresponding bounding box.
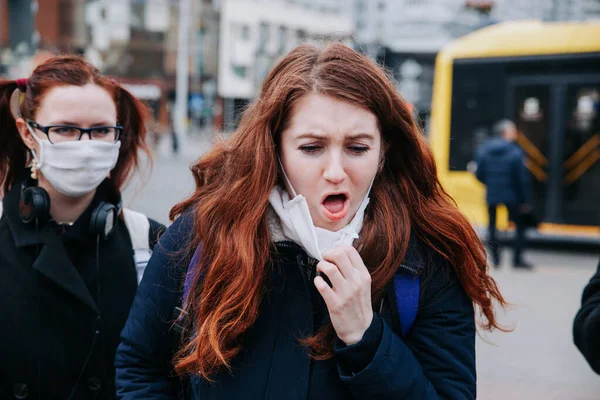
[116,217,476,400]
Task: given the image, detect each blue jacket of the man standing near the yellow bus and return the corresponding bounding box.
[476,138,531,207]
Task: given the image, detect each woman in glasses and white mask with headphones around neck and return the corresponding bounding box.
[0,56,162,399]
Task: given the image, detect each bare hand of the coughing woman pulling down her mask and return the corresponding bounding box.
[314,246,373,346]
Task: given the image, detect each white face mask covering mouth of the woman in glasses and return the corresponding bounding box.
[27,124,121,197]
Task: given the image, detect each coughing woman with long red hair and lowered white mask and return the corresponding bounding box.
[116,44,505,399]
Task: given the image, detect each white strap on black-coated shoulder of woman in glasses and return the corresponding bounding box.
[123,208,152,285]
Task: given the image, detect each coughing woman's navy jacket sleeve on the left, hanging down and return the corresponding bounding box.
[115,216,192,399]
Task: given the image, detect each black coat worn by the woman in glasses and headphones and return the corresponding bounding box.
[0,179,161,400]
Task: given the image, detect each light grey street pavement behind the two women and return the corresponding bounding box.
[124,134,600,400]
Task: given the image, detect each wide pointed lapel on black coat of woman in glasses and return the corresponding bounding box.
[33,235,98,312]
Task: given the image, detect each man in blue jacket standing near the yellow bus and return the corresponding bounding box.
[476,120,532,269]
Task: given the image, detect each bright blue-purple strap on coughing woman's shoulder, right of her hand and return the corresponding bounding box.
[394,272,420,337]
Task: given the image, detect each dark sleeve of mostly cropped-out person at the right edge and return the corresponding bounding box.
[573,263,600,374]
